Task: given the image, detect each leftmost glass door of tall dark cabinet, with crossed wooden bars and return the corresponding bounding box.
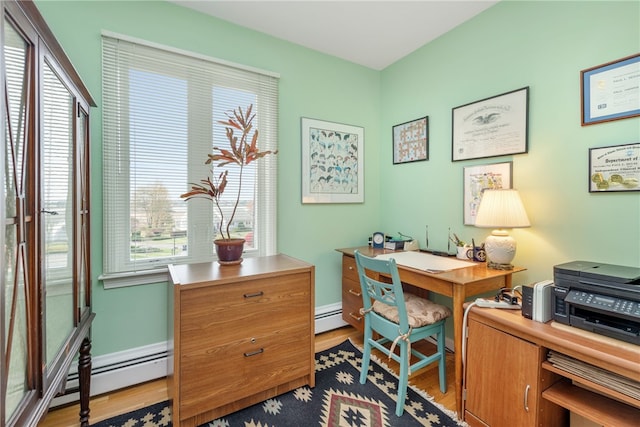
[0,14,37,425]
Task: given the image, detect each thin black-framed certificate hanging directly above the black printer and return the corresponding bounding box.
[589,143,640,193]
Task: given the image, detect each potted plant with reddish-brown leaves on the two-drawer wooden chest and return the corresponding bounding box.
[180,105,278,265]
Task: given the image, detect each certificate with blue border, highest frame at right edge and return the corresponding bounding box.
[580,53,640,126]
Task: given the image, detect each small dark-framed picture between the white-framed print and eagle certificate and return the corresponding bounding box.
[393,116,429,165]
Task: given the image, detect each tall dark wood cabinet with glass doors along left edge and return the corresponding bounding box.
[0,0,95,427]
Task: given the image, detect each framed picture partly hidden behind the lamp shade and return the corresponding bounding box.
[463,162,513,225]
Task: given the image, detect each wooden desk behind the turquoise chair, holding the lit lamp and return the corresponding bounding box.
[336,246,525,417]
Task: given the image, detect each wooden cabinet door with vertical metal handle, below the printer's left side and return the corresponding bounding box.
[465,319,541,427]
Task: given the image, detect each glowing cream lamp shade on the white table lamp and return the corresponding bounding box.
[475,190,531,228]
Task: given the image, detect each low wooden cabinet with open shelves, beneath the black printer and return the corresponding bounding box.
[464,307,640,427]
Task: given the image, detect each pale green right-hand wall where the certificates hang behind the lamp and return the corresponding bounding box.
[380,1,640,284]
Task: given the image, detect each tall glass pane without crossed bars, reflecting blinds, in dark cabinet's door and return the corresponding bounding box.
[40,60,75,367]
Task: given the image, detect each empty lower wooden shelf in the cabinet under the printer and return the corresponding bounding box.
[542,382,640,427]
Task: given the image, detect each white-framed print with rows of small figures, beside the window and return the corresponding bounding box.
[301,117,364,203]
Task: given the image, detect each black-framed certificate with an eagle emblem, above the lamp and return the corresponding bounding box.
[451,87,529,162]
